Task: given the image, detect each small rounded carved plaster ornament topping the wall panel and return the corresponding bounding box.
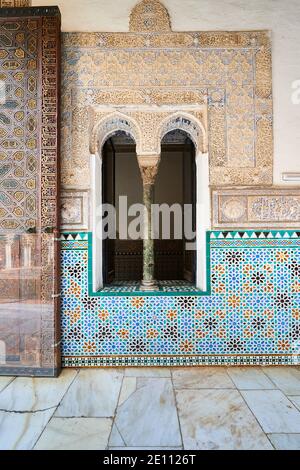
[129,0,171,33]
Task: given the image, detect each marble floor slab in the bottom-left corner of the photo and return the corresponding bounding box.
[0,409,54,450]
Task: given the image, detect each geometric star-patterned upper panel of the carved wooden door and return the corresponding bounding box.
[0,18,40,232]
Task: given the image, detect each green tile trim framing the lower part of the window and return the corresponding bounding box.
[88,232,211,297]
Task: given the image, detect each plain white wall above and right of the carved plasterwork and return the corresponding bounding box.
[32,0,300,185]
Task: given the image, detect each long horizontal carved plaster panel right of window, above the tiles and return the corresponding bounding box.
[213,188,300,229]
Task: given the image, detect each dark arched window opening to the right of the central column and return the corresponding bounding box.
[154,130,197,285]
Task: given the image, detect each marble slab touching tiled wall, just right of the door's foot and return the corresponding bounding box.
[55,369,124,418]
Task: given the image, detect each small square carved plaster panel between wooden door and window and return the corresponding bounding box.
[60,190,89,231]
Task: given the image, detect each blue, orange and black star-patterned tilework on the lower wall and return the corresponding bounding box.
[61,230,300,367]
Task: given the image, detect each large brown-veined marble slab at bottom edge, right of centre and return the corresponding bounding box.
[176,390,272,450]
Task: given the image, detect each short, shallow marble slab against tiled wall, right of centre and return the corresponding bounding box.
[172,367,235,390]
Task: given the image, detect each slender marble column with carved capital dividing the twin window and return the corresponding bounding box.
[138,155,160,291]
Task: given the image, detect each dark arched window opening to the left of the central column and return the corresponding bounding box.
[102,131,143,286]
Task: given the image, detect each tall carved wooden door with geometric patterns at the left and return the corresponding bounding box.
[0,7,60,376]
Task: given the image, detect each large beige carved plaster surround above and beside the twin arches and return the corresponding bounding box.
[62,1,273,195]
